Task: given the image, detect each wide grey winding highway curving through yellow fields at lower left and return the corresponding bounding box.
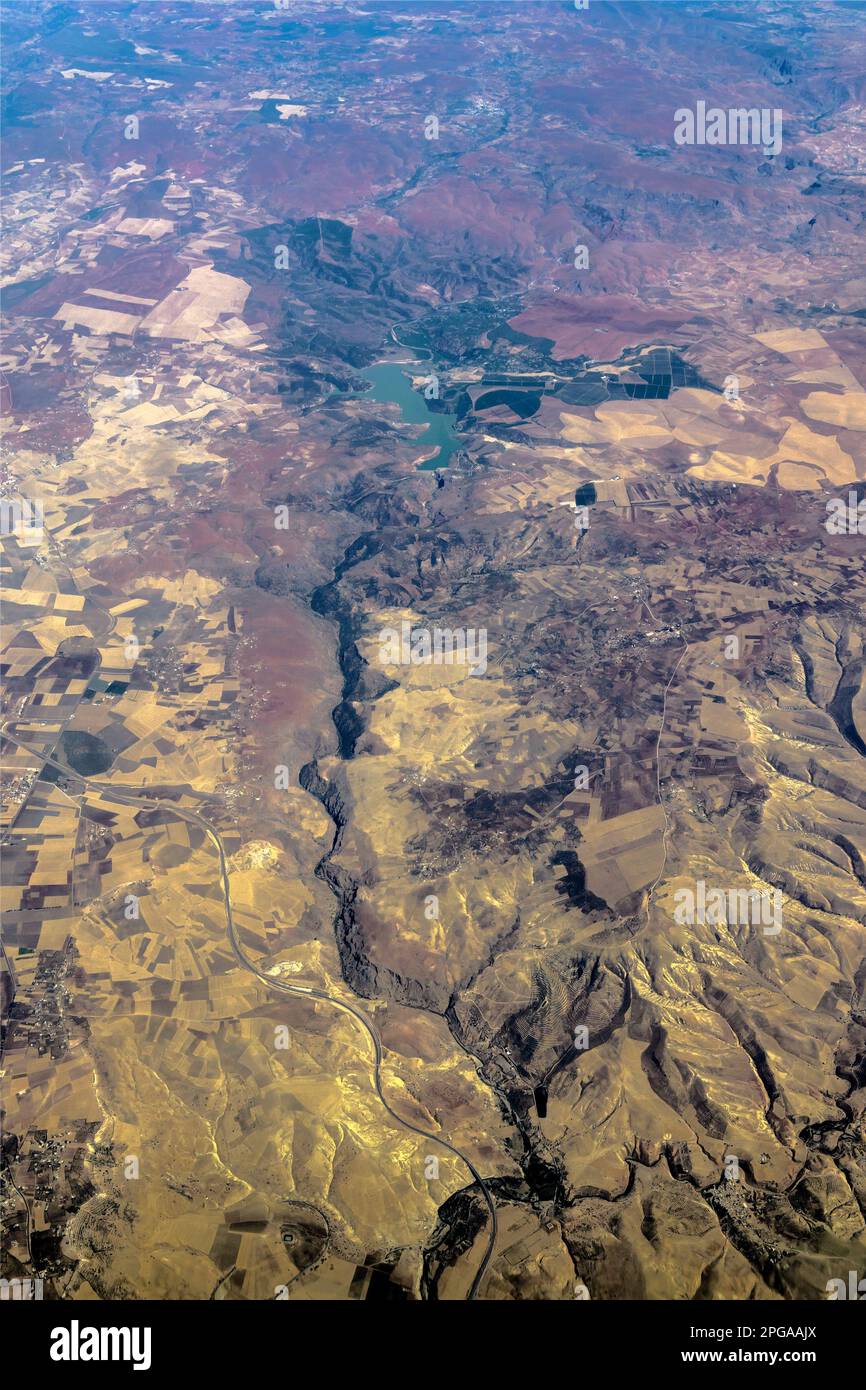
[1,728,498,1300]
